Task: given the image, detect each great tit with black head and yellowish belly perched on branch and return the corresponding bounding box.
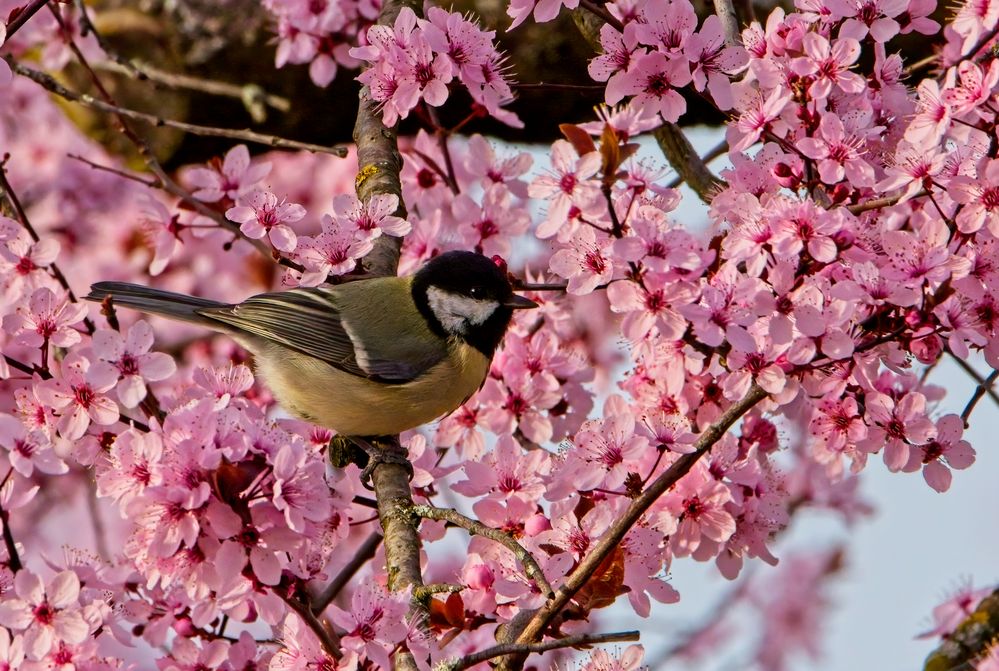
[86,251,537,436]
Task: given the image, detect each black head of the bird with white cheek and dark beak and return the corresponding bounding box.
[413,252,537,357]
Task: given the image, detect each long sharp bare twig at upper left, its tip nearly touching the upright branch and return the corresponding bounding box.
[4,56,347,158]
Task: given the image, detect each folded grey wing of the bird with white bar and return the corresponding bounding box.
[197,285,447,384]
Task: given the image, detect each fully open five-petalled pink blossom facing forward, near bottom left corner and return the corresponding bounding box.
[0,569,90,660]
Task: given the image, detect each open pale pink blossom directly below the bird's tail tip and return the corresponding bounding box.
[93,320,177,408]
